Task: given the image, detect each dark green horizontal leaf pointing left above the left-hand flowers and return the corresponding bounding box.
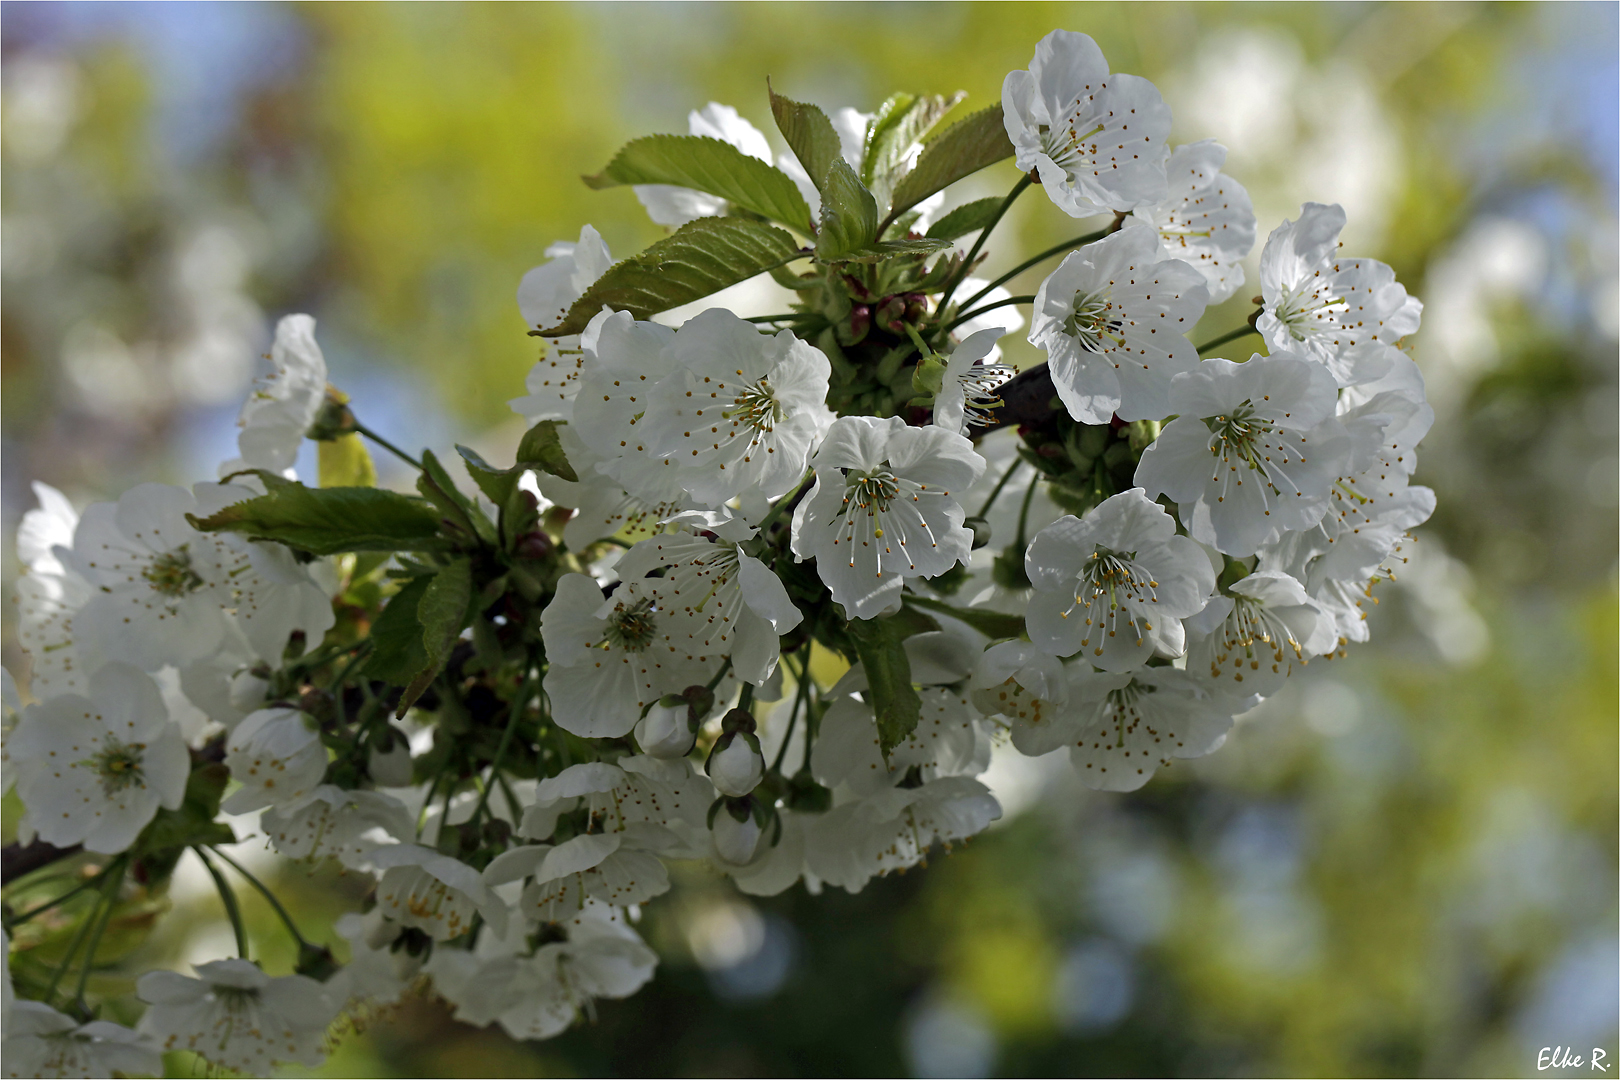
[186,483,447,555]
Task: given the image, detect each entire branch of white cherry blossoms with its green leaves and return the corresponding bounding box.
[3,31,1434,1075]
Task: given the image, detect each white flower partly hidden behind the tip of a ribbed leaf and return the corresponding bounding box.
[510,225,612,424]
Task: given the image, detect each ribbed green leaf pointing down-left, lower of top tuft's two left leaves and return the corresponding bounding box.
[541,217,802,337]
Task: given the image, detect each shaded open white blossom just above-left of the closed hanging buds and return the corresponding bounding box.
[539,573,721,738]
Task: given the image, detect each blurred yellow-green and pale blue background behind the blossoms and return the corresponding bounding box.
[0,3,1620,1077]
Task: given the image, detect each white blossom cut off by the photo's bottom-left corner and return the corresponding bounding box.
[0,1001,164,1077]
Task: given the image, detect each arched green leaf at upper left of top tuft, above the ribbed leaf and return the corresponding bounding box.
[585,134,810,233]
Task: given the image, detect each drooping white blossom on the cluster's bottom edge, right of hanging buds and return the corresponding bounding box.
[805,776,1001,892]
